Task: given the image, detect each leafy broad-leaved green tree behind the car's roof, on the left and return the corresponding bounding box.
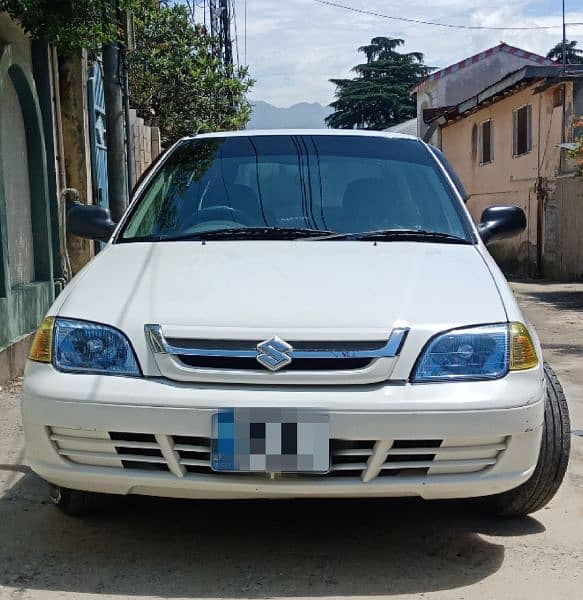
[128,4,253,145]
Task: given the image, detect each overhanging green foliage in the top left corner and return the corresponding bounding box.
[0,0,139,54]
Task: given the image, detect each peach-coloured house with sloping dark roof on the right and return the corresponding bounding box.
[417,57,583,279]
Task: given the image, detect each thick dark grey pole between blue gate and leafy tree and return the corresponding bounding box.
[103,0,129,223]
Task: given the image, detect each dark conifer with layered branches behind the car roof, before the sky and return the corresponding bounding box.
[326,37,430,129]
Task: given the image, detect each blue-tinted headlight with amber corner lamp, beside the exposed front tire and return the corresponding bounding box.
[412,323,538,383]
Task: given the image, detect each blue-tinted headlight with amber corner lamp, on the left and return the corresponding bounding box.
[29,317,140,376]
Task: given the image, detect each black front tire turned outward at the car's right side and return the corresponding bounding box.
[478,362,571,517]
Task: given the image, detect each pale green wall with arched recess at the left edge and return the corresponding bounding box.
[0,13,54,381]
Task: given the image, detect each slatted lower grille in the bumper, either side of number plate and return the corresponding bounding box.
[49,427,508,481]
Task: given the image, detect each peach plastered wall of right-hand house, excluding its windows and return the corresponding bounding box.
[441,83,572,275]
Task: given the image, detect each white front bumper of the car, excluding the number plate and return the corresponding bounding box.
[22,363,544,498]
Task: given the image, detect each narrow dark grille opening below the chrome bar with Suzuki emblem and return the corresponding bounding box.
[178,354,372,372]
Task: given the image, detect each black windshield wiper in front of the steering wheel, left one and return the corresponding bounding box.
[134,227,334,242]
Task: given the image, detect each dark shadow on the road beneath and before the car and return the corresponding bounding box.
[0,474,544,598]
